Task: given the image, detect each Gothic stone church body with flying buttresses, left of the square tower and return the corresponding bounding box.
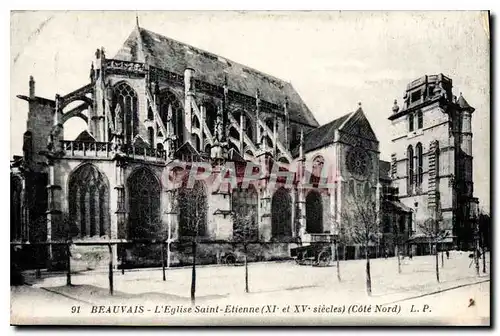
[11,25,414,264]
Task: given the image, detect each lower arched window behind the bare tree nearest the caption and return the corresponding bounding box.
[178,181,207,237]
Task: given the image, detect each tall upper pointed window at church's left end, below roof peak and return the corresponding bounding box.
[111,82,139,143]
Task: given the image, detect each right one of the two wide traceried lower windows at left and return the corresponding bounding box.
[127,168,160,239]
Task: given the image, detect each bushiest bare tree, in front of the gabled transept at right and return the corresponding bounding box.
[343,194,379,295]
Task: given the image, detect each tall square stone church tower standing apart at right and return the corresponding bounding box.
[389,74,477,251]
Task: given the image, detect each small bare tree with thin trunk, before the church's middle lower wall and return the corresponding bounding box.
[231,208,258,293]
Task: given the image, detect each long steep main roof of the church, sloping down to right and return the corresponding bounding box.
[115,27,319,126]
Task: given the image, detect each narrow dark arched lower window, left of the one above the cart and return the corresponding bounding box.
[271,188,292,239]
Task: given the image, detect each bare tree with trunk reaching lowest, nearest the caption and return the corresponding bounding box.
[178,181,208,304]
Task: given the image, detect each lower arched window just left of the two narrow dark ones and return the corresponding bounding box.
[232,185,258,241]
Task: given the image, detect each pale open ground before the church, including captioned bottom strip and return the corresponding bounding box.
[11,252,490,325]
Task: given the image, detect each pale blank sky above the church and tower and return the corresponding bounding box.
[10,11,490,210]
